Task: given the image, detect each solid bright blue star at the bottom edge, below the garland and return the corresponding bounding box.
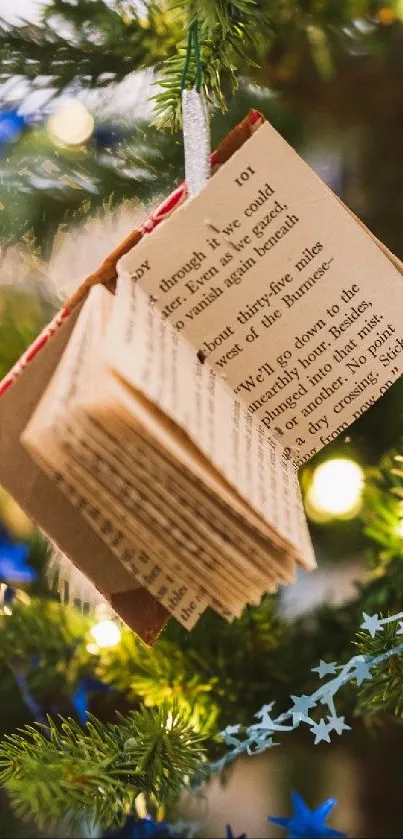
[268,792,346,839]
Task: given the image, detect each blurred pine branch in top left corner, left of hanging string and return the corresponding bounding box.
[0,0,178,91]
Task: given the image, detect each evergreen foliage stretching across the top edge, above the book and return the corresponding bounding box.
[0,0,402,127]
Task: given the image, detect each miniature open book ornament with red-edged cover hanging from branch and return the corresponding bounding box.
[0,112,403,642]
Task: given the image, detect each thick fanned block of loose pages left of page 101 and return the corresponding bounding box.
[22,277,314,628]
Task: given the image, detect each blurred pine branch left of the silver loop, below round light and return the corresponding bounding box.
[0,121,183,249]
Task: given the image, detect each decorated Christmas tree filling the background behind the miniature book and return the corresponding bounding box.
[0,0,403,836]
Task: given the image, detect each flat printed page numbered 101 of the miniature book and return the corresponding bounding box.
[119,123,403,464]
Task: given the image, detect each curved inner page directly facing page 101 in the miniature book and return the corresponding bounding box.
[104,277,314,571]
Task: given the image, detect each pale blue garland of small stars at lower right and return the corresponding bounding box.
[210,612,403,776]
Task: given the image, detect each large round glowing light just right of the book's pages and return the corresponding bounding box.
[307,458,364,518]
